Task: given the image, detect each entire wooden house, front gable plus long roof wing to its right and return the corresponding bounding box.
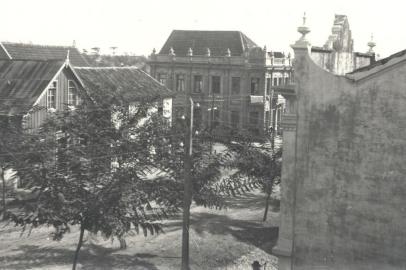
[0,59,174,129]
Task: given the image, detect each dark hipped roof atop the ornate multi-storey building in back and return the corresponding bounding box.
[159,30,258,56]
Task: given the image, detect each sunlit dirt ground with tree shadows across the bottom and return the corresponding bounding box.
[0,191,278,270]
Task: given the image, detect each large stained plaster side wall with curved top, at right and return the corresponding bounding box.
[290,50,406,270]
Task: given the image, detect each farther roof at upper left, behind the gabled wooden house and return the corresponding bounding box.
[0,42,89,66]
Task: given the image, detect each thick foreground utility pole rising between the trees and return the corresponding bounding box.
[181,95,193,270]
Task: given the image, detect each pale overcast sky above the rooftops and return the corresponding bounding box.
[0,0,406,57]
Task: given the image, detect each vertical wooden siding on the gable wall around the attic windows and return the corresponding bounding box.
[25,68,84,129]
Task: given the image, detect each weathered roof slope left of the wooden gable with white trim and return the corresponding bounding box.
[0,60,63,114]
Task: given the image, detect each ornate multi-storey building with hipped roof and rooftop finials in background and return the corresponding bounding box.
[148,30,292,135]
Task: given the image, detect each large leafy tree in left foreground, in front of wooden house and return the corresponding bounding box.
[8,88,170,269]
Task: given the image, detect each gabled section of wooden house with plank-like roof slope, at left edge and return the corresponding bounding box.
[0,60,85,129]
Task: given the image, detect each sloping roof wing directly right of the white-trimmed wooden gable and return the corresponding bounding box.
[74,67,175,102]
